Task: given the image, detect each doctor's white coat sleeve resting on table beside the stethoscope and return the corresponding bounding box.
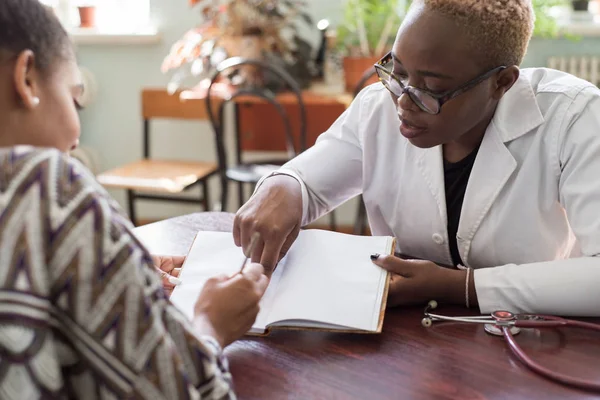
[471,89,600,316]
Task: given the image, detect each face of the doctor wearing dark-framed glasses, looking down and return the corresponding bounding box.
[386,6,514,148]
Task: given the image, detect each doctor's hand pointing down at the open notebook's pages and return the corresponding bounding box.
[233,175,302,276]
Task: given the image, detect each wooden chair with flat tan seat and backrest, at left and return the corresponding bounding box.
[98,89,219,225]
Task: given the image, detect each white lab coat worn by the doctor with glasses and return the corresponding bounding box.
[264,69,600,316]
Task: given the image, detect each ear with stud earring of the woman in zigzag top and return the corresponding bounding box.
[13,50,42,110]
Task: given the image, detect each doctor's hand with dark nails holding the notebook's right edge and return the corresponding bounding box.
[371,255,474,306]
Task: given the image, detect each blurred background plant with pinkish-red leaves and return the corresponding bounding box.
[162,0,316,92]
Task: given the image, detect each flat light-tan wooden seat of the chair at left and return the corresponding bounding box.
[98,159,219,193]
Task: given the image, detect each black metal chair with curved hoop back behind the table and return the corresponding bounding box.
[206,57,306,210]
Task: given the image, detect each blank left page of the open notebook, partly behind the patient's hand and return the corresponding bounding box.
[171,232,283,333]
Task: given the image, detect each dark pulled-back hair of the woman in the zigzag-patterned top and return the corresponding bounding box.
[0,0,72,72]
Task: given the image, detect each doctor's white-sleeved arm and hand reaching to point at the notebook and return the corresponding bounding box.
[233,88,372,269]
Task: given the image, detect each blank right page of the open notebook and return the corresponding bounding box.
[268,229,392,331]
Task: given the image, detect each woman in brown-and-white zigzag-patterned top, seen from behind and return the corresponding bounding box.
[0,0,267,400]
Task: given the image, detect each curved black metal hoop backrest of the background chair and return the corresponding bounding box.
[206,57,307,168]
